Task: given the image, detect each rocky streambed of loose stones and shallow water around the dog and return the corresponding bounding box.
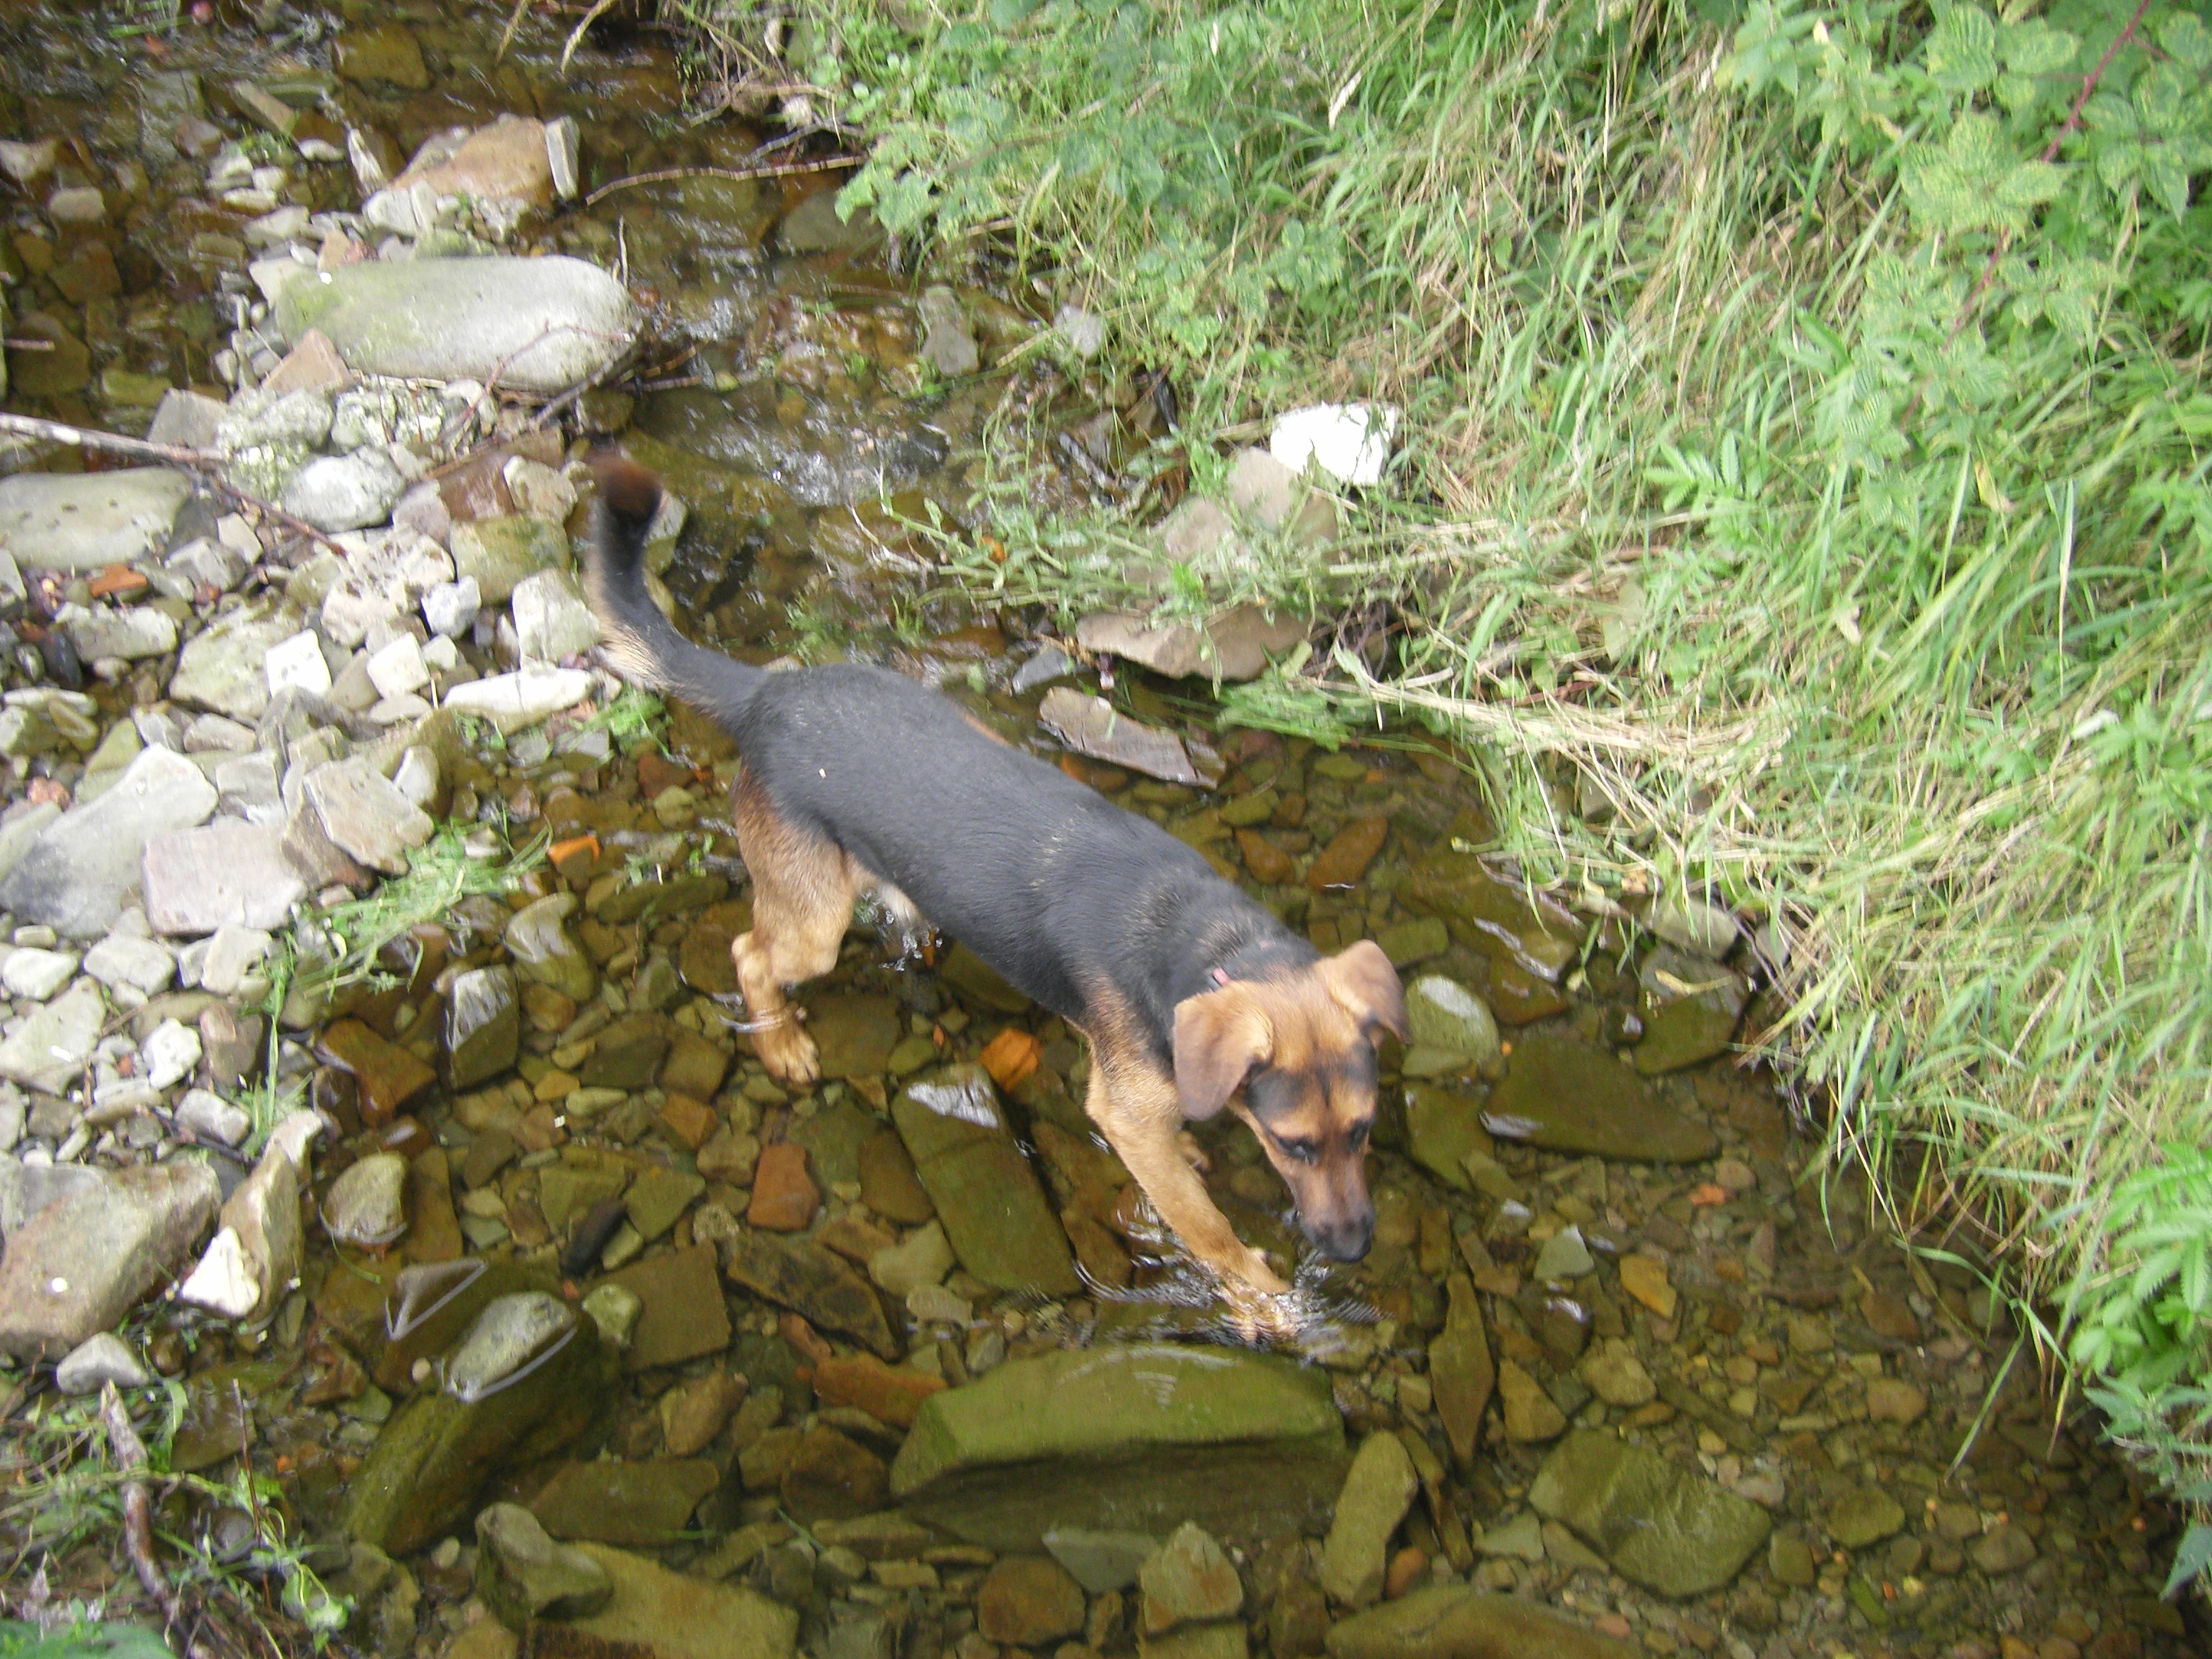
[0,6,2194,1659]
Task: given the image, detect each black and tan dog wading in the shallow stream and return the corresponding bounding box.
[588,456,1405,1323]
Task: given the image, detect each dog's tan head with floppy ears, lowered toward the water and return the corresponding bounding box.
[1174,940,1405,1261]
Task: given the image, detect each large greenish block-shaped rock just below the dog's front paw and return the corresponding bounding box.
[891,1345,1345,1550]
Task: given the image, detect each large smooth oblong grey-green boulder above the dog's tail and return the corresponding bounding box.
[272,253,637,394]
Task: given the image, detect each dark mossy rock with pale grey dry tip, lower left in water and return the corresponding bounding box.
[341,1292,615,1555]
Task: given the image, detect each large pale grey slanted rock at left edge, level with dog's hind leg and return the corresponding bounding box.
[0,750,215,938]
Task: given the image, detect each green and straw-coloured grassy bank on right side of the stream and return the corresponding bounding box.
[695,0,2212,1573]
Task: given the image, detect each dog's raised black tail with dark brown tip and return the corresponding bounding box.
[584,451,763,739]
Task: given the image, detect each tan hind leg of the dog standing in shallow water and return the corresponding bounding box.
[730,774,867,1086]
